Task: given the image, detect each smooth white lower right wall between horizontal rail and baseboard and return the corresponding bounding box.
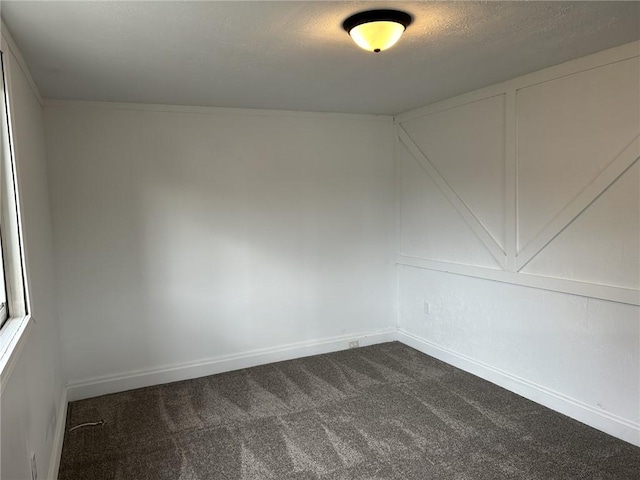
[399,266,640,432]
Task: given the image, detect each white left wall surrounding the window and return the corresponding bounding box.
[0,32,66,480]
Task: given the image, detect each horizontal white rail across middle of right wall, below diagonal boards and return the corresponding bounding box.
[396,255,640,305]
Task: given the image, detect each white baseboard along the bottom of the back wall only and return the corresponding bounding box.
[67,327,397,402]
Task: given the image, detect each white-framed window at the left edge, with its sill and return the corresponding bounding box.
[0,47,29,356]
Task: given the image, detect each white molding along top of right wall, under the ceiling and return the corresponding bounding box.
[395,41,640,124]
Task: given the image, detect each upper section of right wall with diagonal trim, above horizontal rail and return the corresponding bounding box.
[398,46,640,304]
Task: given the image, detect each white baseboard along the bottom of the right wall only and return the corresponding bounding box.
[396,329,640,446]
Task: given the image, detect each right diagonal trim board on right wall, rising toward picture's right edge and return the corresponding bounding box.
[516,135,640,271]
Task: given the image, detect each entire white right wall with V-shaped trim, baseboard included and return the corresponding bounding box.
[397,43,640,444]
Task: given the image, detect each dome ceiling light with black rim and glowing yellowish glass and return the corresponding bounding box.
[342,10,413,53]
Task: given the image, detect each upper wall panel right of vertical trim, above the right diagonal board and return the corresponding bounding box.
[517,58,640,250]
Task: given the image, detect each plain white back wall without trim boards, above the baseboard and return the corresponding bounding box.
[45,102,395,394]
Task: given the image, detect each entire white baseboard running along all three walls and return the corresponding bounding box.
[58,327,640,448]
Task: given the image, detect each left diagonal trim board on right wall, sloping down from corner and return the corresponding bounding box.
[398,125,506,268]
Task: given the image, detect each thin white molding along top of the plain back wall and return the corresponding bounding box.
[43,99,393,124]
